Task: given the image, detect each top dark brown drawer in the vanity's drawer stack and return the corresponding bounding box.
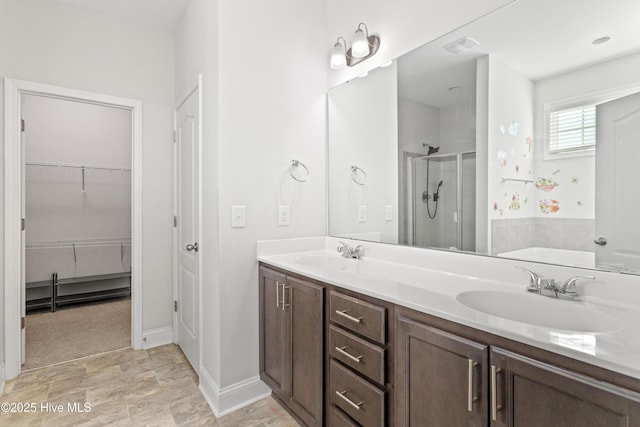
[329,291,386,344]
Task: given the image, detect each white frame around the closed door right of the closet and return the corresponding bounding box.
[173,74,202,375]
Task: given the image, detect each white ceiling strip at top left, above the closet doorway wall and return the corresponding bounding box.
[57,0,189,32]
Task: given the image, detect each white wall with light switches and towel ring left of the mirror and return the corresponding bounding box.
[176,0,327,412]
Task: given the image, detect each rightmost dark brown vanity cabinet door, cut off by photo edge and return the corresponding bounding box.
[491,348,640,427]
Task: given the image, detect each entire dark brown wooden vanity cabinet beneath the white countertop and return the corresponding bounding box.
[260,265,640,427]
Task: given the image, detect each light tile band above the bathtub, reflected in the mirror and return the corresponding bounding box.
[491,218,595,255]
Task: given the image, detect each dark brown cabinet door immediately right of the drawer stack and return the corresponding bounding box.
[395,316,489,427]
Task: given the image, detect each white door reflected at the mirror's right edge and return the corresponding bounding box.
[594,93,640,271]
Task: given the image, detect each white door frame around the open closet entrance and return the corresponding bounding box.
[4,77,143,379]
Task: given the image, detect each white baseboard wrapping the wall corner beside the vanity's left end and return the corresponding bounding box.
[200,367,271,418]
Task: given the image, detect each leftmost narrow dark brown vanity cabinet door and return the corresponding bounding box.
[259,267,290,399]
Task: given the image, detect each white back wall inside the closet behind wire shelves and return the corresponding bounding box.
[22,95,132,282]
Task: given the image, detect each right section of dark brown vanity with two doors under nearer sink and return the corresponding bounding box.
[394,310,640,427]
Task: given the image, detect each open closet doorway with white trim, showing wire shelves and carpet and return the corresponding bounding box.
[5,79,141,378]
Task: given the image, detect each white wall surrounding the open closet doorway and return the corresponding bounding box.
[0,0,174,362]
